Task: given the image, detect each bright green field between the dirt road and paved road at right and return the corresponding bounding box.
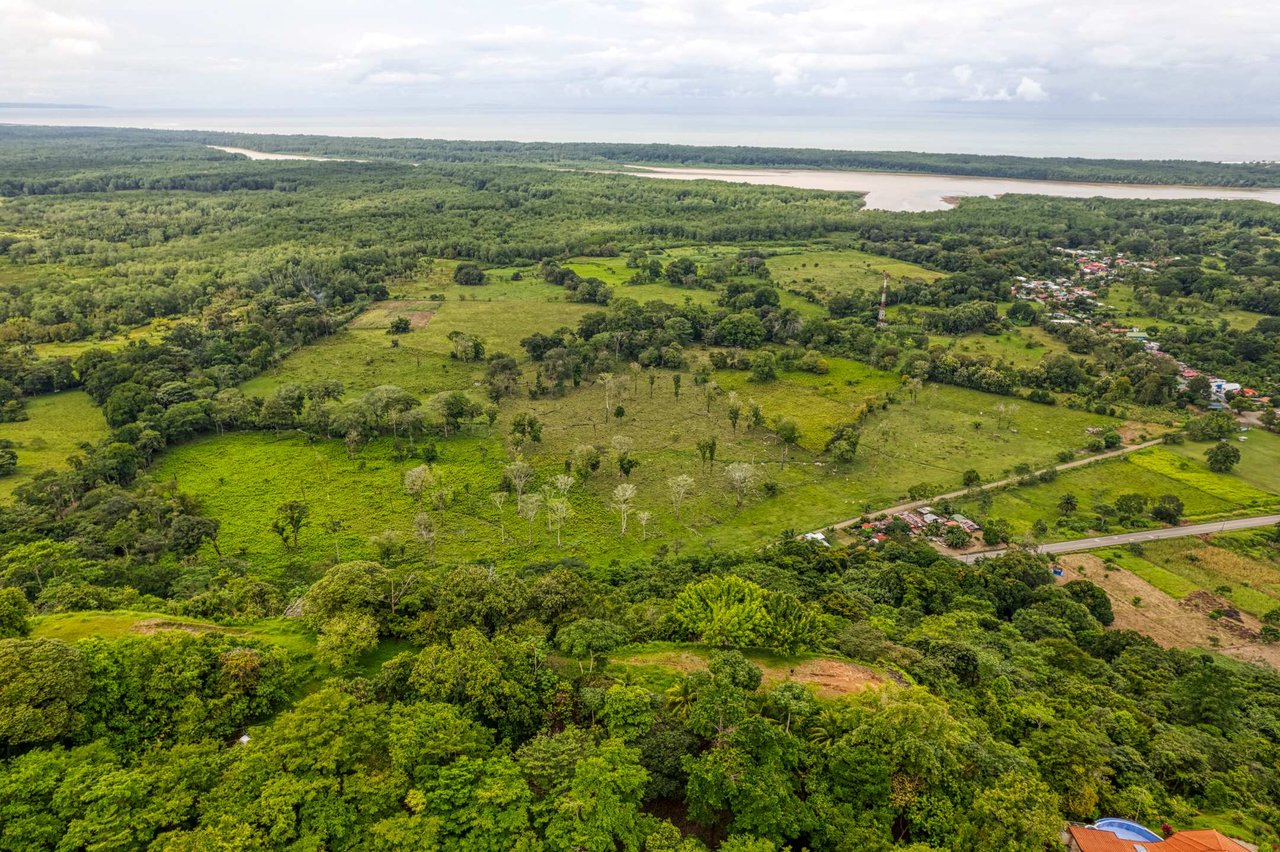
[961,432,1280,540]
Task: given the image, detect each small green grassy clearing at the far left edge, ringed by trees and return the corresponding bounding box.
[0,390,106,499]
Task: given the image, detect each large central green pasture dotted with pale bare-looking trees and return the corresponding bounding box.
[151,368,1114,565]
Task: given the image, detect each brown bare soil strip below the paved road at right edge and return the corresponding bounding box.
[1059,554,1280,669]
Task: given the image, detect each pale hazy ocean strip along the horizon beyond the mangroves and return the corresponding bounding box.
[0,107,1280,161]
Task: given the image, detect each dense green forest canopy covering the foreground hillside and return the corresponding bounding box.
[0,532,1280,852]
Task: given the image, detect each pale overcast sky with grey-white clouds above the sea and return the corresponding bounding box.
[0,0,1280,122]
